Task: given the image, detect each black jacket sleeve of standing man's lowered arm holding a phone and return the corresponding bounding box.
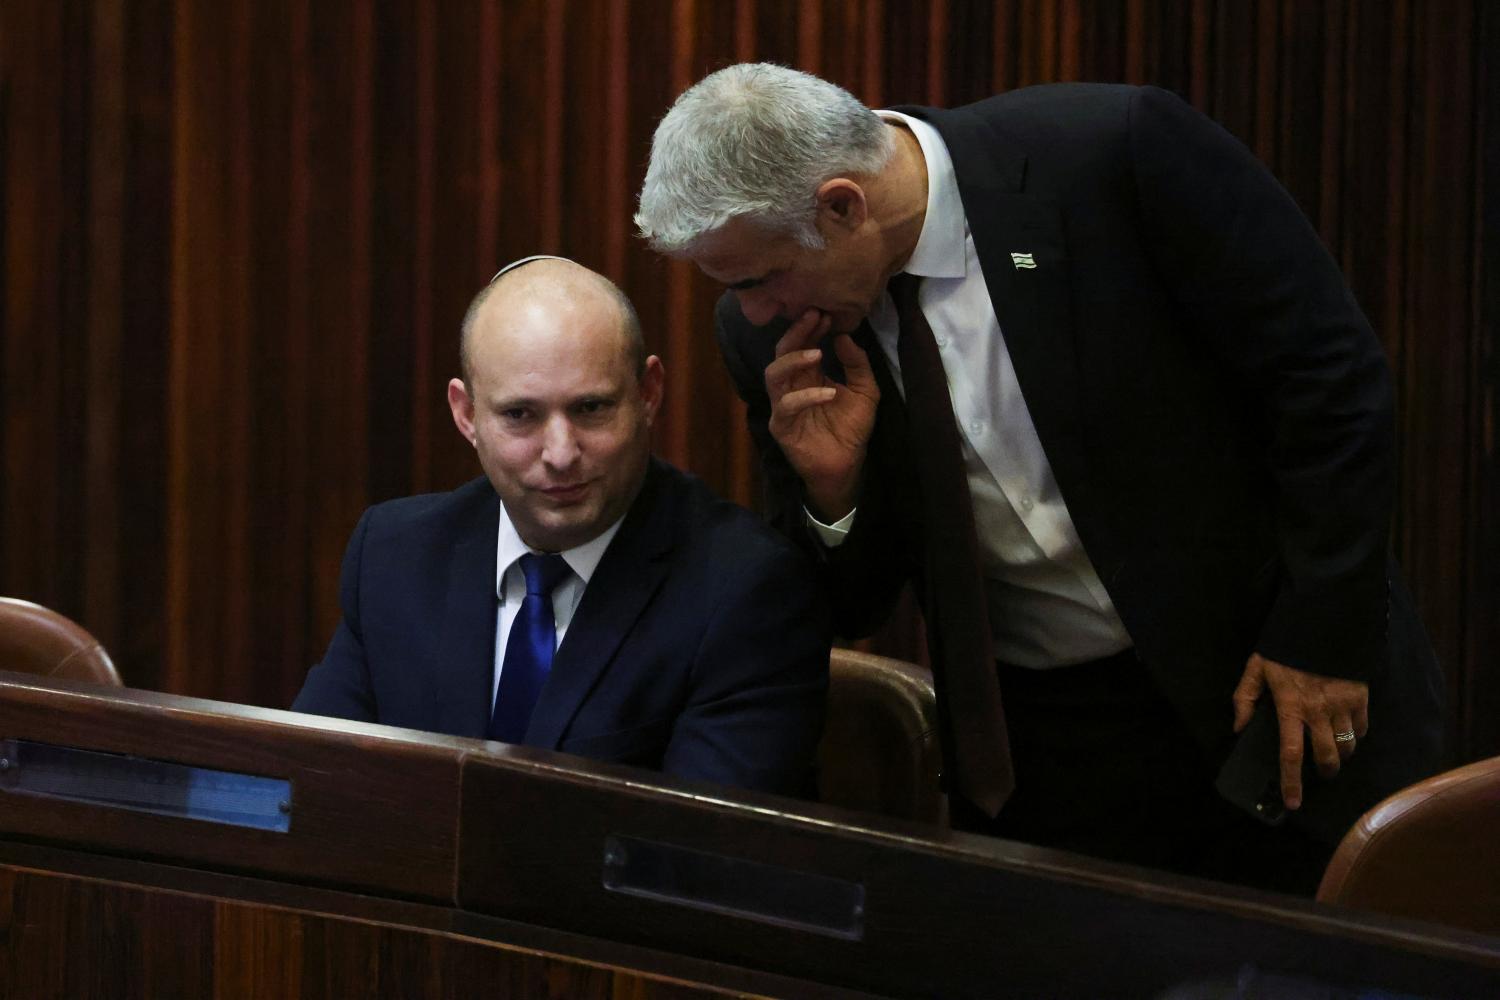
[1130,87,1395,679]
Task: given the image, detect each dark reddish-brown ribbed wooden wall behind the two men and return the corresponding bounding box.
[0,0,1500,757]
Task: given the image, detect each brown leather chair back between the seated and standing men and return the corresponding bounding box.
[818,649,948,825]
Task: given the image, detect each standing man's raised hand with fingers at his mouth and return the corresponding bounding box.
[765,309,881,522]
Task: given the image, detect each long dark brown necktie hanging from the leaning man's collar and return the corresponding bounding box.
[891,274,1016,817]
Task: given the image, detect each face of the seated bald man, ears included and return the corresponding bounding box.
[449,289,663,552]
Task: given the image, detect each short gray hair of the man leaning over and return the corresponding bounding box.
[636,63,896,253]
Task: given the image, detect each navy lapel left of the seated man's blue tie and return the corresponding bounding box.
[432,490,500,738]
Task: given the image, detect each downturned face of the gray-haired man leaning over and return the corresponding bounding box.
[687,219,887,333]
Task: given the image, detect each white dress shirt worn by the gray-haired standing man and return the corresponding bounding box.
[809,111,1131,667]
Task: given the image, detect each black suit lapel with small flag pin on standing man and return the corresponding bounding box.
[903,108,1085,496]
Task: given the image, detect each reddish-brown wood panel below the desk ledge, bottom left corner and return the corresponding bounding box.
[0,865,750,1000]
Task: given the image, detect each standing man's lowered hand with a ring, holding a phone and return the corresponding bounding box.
[1233,654,1370,810]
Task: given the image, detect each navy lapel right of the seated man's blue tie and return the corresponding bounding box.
[525,459,675,748]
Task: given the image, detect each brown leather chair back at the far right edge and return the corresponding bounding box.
[1317,757,1500,934]
